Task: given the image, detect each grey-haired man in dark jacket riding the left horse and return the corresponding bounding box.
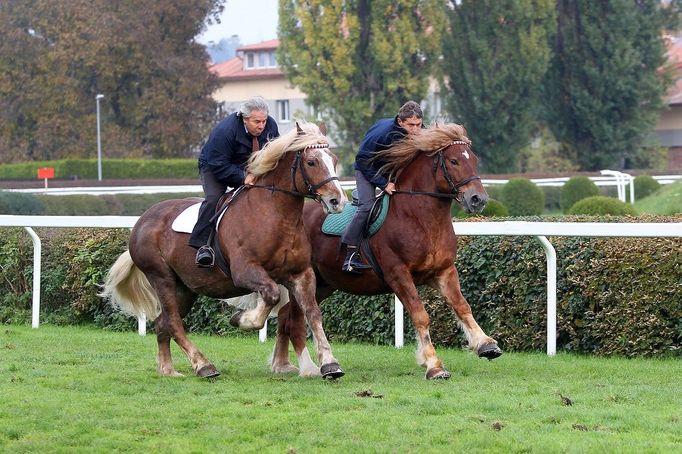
[189,96,279,267]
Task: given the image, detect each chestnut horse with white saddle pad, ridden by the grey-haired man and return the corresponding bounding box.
[101,124,347,378]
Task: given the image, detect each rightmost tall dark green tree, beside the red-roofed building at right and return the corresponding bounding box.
[545,0,674,170]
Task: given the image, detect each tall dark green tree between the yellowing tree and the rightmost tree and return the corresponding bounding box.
[443,0,555,173]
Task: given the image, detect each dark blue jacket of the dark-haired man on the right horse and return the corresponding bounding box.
[354,116,407,189]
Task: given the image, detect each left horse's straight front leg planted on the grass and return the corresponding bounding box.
[287,267,344,379]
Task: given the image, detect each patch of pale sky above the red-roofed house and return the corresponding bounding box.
[197,0,278,45]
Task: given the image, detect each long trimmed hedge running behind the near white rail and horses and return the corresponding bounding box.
[0,215,682,357]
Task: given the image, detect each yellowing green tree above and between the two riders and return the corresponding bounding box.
[278,0,444,168]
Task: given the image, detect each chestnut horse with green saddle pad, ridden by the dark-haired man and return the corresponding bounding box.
[272,124,502,379]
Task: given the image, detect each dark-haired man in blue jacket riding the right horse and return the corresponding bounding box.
[341,101,424,273]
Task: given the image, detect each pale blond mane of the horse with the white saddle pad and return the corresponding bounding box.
[247,121,328,177]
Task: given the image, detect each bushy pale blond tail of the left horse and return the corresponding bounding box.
[99,251,161,320]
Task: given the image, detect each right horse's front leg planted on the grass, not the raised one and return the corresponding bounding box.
[387,269,450,380]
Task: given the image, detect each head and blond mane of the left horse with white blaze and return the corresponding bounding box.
[248,122,348,213]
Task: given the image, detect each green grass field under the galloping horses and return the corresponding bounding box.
[0,325,682,453]
